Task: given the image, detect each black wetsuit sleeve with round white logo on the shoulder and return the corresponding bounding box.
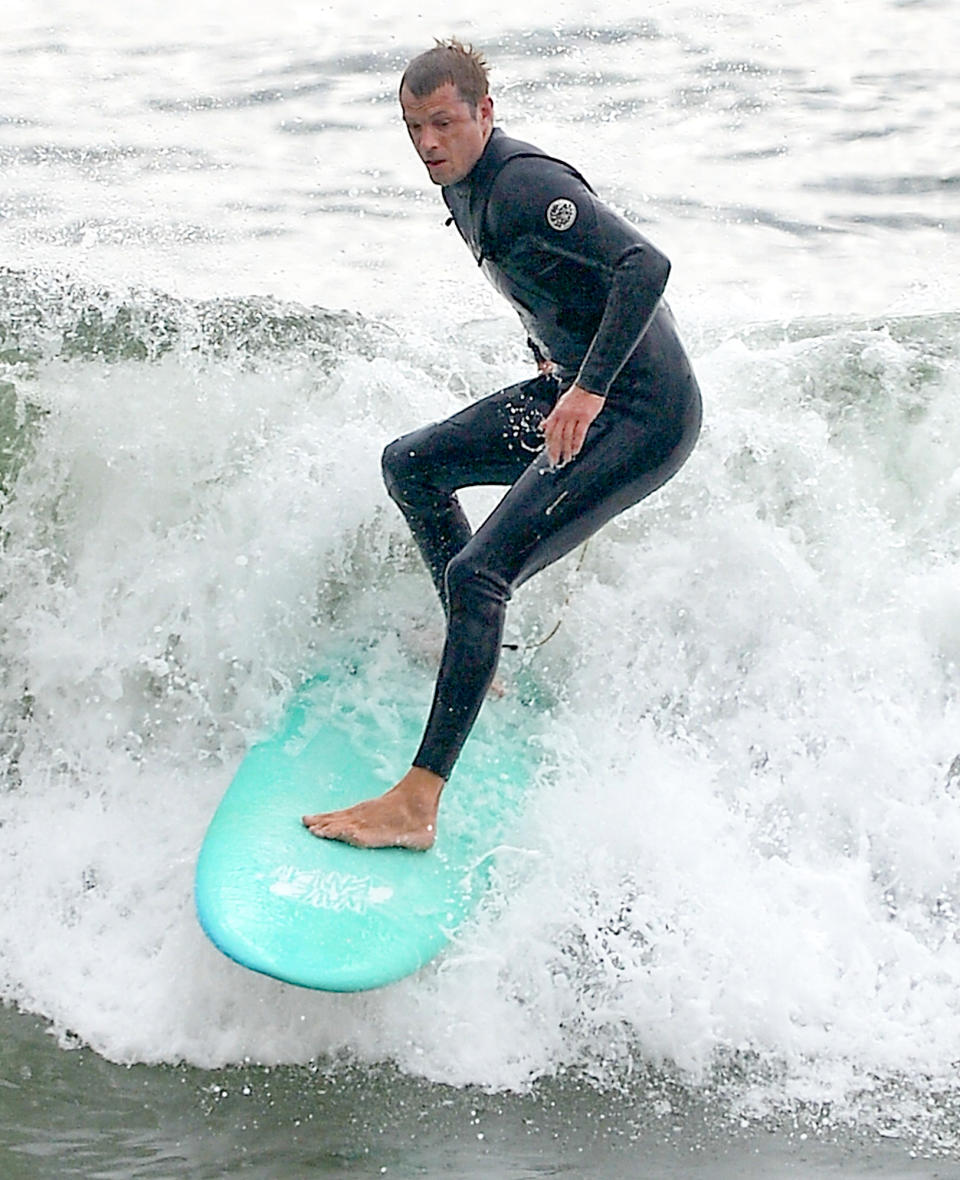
[487,157,670,396]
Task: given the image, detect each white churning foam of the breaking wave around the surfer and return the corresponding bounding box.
[0,283,960,1132]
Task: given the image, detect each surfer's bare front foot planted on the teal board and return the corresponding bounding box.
[303,766,443,852]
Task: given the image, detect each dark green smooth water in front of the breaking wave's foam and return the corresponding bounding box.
[7,1010,960,1180]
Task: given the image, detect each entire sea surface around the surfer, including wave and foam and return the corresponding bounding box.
[0,0,960,1180]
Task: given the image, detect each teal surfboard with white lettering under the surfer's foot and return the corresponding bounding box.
[195,650,532,991]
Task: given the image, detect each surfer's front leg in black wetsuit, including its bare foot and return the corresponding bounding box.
[304,384,699,848]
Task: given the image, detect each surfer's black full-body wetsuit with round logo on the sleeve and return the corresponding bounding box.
[383,129,701,779]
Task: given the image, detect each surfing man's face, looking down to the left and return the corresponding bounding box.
[400,81,493,184]
